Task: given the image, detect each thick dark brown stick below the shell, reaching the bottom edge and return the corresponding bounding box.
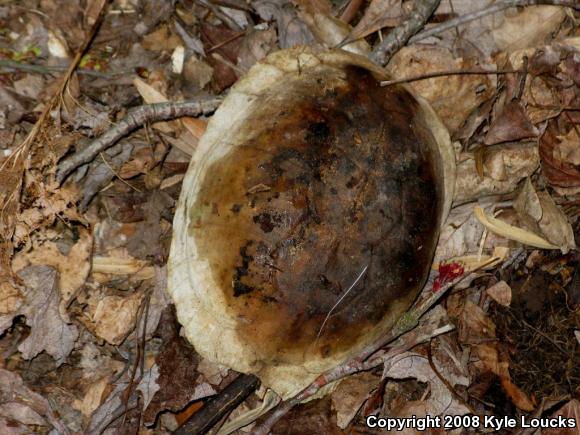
[174,374,260,435]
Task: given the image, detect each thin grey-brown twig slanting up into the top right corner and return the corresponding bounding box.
[409,0,580,44]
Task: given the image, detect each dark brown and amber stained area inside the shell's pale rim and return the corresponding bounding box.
[190,67,442,363]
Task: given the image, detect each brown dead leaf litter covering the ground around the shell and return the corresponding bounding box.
[0,0,580,434]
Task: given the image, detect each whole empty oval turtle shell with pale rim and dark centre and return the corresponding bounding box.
[169,47,454,397]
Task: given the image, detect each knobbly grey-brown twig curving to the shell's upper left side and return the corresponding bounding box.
[56,98,221,184]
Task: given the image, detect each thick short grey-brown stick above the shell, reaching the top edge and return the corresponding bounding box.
[369,0,441,65]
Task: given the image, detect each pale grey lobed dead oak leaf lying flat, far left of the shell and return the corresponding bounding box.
[18,265,79,365]
